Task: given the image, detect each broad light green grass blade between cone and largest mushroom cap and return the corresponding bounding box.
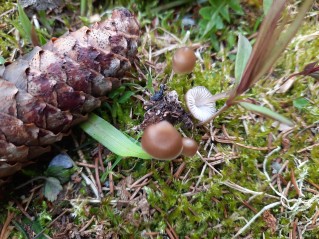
[80,114,152,159]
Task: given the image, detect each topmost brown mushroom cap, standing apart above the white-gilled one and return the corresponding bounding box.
[173,47,196,74]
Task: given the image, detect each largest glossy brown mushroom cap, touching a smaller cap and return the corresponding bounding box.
[141,121,183,160]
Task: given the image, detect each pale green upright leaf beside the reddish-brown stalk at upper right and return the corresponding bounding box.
[235,34,252,83]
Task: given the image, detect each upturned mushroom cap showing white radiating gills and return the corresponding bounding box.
[185,86,216,121]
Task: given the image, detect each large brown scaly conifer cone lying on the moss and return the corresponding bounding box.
[0,9,139,185]
